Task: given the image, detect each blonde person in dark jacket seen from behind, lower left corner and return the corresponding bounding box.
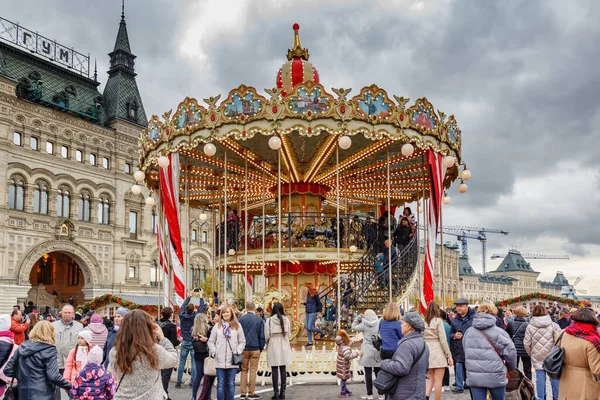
[4,321,71,400]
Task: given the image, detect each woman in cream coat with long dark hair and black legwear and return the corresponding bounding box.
[265,303,292,400]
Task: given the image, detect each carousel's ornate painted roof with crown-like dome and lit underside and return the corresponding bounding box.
[140,24,461,208]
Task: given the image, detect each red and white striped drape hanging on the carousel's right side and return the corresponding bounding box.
[421,149,446,315]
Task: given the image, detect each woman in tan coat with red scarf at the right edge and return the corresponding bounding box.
[558,307,600,400]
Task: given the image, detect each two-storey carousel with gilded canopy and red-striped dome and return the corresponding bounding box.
[136,24,470,338]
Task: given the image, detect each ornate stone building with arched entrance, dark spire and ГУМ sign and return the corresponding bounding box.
[0,15,218,312]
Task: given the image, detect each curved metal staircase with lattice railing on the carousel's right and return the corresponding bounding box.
[319,230,419,328]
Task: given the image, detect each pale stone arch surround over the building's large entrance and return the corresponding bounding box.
[17,239,100,290]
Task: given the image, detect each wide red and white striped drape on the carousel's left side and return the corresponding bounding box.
[160,153,186,305]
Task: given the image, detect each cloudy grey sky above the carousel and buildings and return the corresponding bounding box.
[0,0,600,295]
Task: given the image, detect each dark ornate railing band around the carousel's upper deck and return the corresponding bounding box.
[216,213,383,255]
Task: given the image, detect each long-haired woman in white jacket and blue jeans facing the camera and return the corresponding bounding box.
[208,305,246,400]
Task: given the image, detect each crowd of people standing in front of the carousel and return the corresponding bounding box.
[0,290,600,400]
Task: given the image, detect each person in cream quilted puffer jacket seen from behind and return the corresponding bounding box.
[523,304,560,399]
